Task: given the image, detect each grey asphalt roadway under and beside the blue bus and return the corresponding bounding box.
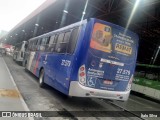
[1,57,160,120]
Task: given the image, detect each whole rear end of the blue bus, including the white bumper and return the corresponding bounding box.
[69,19,138,101]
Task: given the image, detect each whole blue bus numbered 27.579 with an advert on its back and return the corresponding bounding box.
[25,18,138,101]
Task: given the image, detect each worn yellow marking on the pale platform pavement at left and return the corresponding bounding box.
[0,89,20,98]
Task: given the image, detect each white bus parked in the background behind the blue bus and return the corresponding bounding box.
[13,41,28,63]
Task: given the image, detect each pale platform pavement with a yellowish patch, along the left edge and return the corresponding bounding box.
[0,57,32,120]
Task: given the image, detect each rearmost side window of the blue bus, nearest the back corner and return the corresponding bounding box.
[67,27,79,54]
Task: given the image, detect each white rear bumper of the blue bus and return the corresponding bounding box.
[69,81,130,101]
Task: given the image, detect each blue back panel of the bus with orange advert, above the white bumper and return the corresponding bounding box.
[79,23,137,91]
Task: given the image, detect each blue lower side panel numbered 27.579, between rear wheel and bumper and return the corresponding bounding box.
[41,53,73,95]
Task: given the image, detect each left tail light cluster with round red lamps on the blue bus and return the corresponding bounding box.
[78,65,86,86]
